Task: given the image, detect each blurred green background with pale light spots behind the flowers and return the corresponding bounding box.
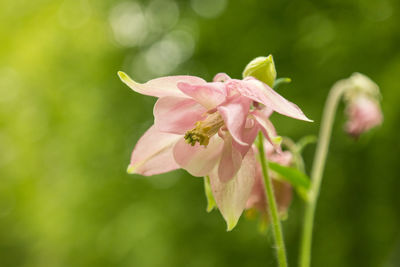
[0,0,400,267]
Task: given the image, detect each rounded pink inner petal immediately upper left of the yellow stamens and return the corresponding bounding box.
[153,96,207,134]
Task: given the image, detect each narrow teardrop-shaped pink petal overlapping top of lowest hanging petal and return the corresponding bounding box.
[218,133,242,182]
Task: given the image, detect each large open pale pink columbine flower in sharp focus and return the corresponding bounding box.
[118,72,309,229]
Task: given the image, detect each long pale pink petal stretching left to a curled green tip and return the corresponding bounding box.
[118,71,206,97]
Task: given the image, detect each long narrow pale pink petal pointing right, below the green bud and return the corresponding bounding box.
[238,79,312,121]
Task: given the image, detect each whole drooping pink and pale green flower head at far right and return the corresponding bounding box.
[336,73,383,137]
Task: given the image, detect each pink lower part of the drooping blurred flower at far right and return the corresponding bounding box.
[346,95,383,137]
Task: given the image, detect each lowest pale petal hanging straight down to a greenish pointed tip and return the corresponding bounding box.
[210,150,256,231]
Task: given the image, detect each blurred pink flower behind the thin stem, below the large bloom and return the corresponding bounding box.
[246,142,293,220]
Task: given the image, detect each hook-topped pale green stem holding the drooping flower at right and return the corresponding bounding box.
[299,86,345,267]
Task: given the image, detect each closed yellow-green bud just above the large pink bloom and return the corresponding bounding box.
[243,55,276,87]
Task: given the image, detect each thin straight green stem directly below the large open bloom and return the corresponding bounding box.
[258,132,287,267]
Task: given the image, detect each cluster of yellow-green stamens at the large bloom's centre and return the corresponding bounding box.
[185,112,224,146]
